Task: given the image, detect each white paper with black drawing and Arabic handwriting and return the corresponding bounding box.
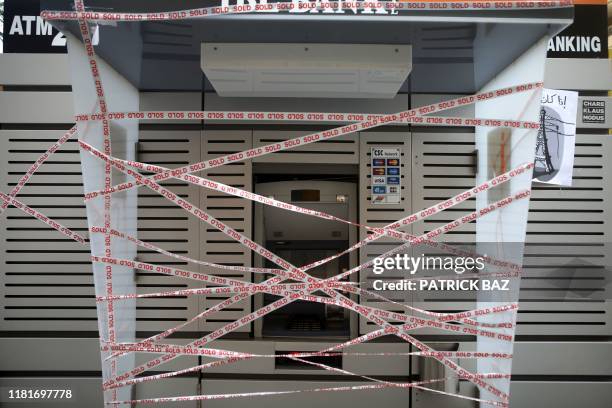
[533,89,578,186]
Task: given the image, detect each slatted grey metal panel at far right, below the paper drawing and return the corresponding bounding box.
[517,133,612,336]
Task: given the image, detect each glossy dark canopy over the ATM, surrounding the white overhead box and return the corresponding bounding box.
[41,0,573,93]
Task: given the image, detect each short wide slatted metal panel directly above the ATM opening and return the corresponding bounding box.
[253,130,359,164]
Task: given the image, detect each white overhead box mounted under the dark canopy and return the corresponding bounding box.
[201,43,412,98]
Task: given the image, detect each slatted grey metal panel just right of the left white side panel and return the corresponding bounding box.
[136,129,200,331]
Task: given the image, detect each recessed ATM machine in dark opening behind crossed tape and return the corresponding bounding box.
[254,181,358,339]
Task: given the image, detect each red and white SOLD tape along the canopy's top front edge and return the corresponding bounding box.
[41,0,573,22]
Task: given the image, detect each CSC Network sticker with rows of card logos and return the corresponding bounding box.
[371,147,402,204]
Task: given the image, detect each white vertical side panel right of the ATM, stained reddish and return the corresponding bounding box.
[475,35,548,408]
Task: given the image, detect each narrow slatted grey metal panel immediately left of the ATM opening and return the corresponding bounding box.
[200,130,253,332]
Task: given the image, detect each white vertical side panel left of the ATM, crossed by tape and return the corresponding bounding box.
[66,34,139,402]
